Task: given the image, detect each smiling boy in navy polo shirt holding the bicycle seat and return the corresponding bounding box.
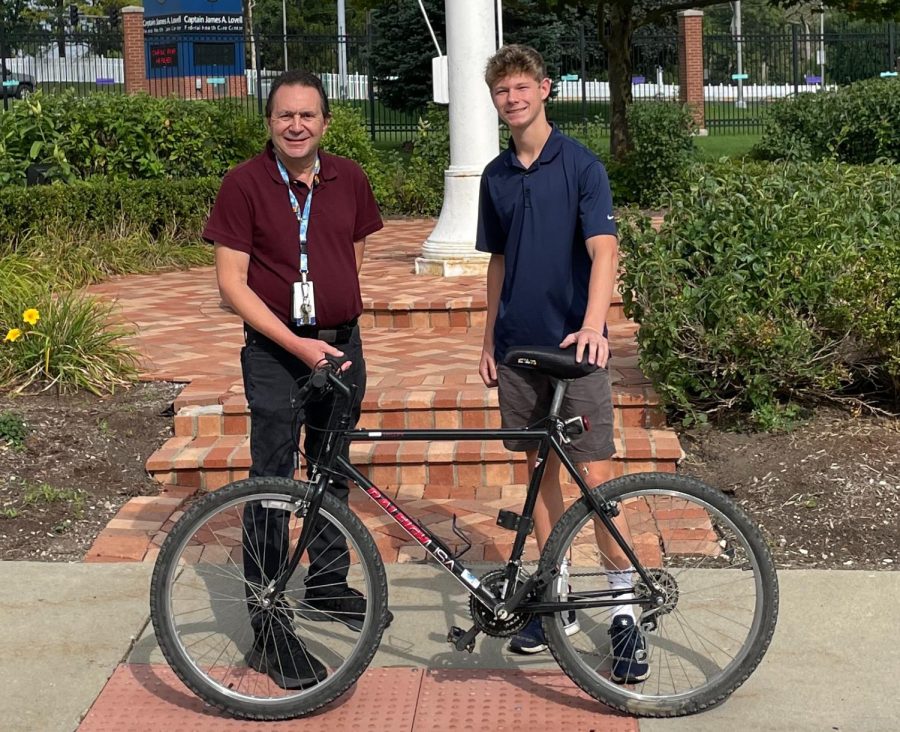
[476,45,649,683]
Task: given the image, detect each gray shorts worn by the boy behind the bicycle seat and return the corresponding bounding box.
[497,364,616,463]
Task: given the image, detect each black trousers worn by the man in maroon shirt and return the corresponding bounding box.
[241,326,366,629]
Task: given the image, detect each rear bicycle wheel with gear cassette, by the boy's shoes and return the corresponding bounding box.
[541,473,778,717]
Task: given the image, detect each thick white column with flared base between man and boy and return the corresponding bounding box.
[416,0,500,277]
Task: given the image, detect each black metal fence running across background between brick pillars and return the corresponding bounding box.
[0,23,898,137]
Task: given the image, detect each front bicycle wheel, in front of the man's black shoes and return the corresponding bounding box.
[150,478,387,720]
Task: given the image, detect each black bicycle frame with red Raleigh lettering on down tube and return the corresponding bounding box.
[279,376,655,613]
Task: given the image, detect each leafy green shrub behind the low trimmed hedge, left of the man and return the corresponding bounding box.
[0,92,265,185]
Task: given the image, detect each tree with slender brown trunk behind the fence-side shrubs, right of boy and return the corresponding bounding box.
[545,0,900,160]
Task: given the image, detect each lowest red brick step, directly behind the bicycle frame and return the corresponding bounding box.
[146,427,682,490]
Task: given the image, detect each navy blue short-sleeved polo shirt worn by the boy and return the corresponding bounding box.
[475,127,616,362]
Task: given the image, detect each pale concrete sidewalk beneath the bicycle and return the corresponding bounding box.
[0,562,900,732]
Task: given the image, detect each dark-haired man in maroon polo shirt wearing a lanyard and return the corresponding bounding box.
[203,71,390,689]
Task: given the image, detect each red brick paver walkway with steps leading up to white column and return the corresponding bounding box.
[87,214,680,561]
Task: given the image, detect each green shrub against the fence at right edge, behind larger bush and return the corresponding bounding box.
[753,79,900,164]
